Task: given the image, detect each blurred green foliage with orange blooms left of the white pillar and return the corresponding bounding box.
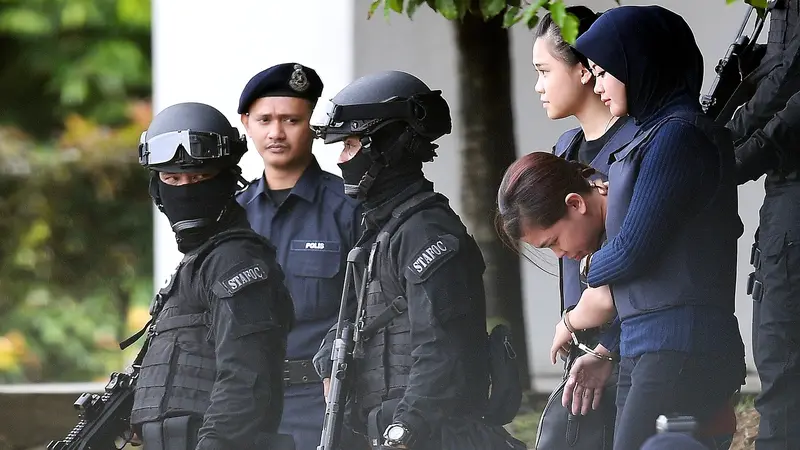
[0,0,153,382]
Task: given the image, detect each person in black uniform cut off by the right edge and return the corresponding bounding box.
[728,0,800,450]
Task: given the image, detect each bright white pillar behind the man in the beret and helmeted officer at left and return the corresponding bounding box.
[152,0,356,286]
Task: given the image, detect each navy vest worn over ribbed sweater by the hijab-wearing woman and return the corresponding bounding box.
[606,113,742,320]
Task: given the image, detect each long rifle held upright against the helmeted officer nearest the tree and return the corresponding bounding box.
[317,247,369,450]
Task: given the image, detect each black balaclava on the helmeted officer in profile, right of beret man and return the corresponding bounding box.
[338,123,432,204]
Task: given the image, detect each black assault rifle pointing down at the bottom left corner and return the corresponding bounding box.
[47,366,139,450]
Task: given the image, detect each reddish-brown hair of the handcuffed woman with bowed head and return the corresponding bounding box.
[495,152,595,248]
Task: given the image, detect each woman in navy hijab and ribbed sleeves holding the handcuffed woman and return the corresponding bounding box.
[565,6,745,450]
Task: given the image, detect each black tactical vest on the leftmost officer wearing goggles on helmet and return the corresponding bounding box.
[131,229,282,424]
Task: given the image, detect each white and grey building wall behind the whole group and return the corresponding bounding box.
[153,0,767,390]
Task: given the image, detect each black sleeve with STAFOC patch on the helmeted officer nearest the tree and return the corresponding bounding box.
[393,217,488,440]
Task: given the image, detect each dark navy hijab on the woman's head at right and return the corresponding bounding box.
[575,6,703,124]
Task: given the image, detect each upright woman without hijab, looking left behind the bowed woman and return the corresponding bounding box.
[532,6,638,448]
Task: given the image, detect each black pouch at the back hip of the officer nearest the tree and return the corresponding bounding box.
[484,325,522,426]
